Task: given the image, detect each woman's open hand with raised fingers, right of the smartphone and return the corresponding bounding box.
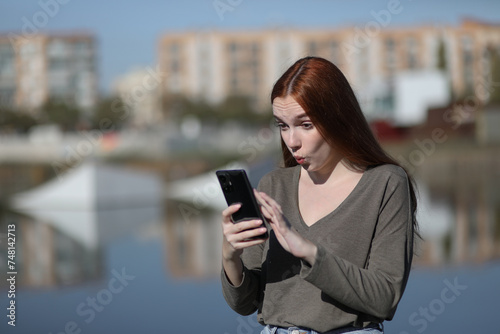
[254,190,318,266]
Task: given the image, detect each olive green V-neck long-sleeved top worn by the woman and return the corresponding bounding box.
[221,165,413,332]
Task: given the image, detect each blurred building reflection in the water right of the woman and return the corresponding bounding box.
[418,150,500,265]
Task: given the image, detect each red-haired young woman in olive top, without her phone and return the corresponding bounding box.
[221,57,417,334]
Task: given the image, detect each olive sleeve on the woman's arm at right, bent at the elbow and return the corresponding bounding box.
[301,168,413,320]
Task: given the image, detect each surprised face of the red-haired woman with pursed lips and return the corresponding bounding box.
[273,96,339,172]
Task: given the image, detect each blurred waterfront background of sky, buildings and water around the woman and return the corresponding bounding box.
[0,0,500,334]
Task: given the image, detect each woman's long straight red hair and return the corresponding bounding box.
[271,57,417,230]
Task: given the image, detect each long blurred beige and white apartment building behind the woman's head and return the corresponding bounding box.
[158,17,500,120]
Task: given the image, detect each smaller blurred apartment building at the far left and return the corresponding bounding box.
[0,33,98,113]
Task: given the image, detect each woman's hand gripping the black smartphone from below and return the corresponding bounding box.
[222,204,267,261]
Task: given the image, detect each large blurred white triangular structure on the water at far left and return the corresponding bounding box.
[10,163,163,248]
